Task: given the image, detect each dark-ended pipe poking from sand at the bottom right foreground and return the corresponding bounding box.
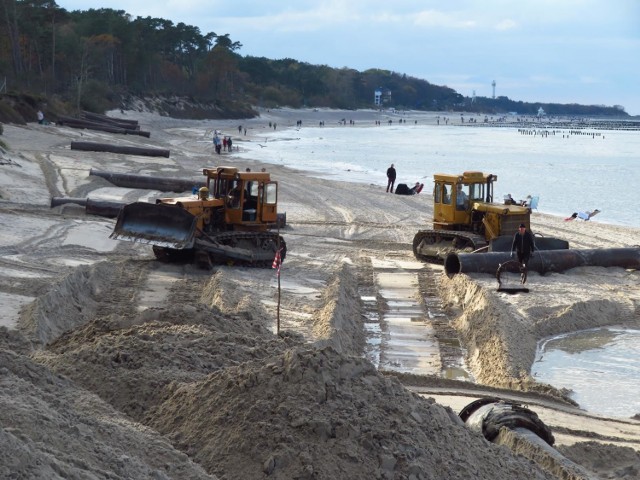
[459,397,597,480]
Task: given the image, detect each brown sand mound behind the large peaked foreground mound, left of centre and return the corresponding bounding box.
[33,294,290,420]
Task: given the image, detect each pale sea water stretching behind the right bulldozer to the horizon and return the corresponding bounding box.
[239,123,640,227]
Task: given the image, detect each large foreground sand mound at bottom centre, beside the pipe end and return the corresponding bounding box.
[147,347,546,479]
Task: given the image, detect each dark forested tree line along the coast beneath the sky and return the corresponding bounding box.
[0,0,624,115]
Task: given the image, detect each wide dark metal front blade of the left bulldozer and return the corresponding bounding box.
[109,202,196,250]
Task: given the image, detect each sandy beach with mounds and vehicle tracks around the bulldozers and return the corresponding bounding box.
[0,106,640,480]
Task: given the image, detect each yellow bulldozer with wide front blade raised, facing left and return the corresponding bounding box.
[110,167,286,268]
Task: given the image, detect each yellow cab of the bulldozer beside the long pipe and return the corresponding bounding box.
[433,172,497,230]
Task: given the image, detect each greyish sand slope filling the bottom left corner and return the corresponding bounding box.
[0,329,214,479]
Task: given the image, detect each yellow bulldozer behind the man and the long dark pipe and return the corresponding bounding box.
[413,172,569,263]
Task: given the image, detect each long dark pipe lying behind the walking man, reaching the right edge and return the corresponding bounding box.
[444,247,640,278]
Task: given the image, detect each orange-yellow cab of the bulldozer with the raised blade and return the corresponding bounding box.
[203,167,278,229]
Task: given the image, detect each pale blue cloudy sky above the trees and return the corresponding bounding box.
[56,0,640,115]
